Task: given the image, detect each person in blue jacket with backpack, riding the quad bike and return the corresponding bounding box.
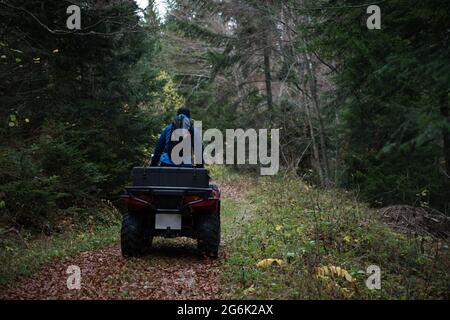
[151,107,203,167]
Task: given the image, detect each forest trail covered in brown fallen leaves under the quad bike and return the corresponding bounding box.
[0,182,253,299]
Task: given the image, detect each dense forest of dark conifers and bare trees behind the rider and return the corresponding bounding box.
[0,0,450,233]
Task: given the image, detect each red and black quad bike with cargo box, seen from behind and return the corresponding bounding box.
[121,167,220,258]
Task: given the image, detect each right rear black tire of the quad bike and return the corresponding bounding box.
[196,203,220,259]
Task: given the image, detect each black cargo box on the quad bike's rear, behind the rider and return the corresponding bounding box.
[131,167,209,188]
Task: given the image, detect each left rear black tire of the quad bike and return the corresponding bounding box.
[120,213,153,257]
